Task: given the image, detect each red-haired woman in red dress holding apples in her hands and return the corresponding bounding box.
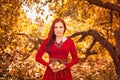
[36,18,78,80]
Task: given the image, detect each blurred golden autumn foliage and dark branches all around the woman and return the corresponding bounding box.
[0,0,120,80]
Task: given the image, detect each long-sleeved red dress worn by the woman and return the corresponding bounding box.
[36,38,78,80]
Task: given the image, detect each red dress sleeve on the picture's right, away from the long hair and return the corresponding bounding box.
[65,40,78,68]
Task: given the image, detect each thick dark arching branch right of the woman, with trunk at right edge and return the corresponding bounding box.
[69,29,120,77]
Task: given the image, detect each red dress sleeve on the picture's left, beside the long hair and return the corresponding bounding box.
[35,40,49,66]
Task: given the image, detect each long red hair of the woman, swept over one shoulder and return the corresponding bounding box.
[47,18,66,52]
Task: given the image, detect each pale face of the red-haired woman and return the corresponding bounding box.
[54,22,65,37]
